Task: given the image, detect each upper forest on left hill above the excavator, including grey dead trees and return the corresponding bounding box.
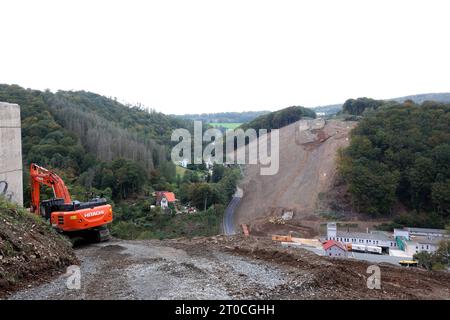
[0,85,190,203]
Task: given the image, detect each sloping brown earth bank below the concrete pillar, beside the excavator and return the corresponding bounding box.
[0,199,77,297]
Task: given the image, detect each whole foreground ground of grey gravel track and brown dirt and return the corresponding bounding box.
[9,236,450,299]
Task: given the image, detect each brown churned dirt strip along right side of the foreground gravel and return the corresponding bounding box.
[217,237,450,299]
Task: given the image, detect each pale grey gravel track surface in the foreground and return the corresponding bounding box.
[9,241,285,299]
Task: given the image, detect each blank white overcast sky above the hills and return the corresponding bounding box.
[0,0,450,114]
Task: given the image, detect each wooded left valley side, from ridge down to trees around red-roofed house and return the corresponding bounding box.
[0,85,239,238]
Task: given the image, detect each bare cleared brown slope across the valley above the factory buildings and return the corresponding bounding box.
[235,119,355,236]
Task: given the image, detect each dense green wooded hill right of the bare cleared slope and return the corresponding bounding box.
[340,99,450,227]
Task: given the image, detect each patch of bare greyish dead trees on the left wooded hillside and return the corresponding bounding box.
[47,91,189,174]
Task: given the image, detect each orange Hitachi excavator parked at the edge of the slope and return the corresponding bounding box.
[30,163,113,242]
